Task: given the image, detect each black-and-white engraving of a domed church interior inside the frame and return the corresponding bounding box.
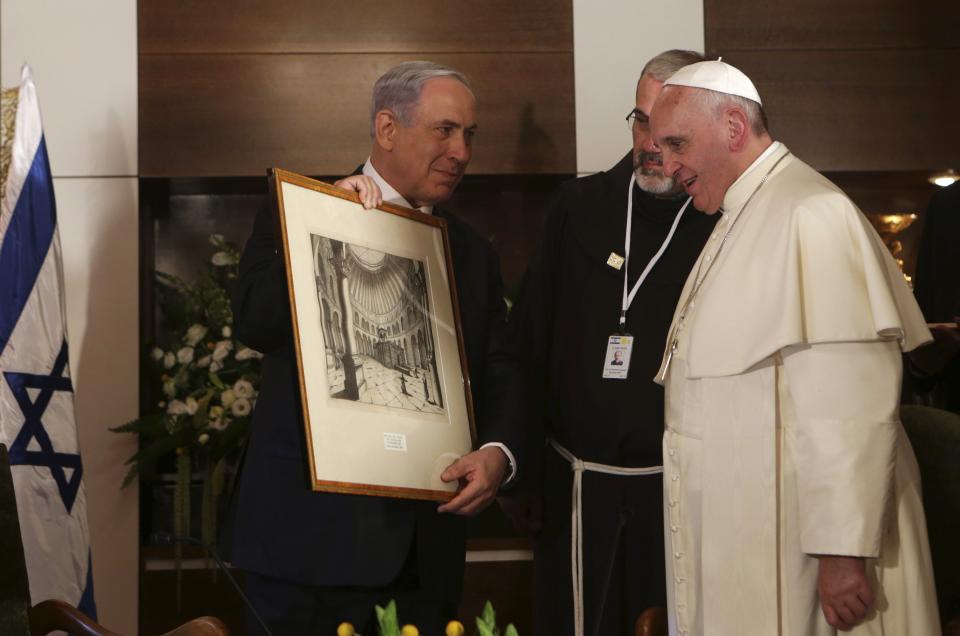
[311,234,444,413]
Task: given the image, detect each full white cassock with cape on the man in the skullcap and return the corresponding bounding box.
[658,143,940,636]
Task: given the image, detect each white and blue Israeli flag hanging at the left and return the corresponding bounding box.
[0,66,96,617]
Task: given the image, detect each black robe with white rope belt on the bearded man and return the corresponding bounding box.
[512,154,715,635]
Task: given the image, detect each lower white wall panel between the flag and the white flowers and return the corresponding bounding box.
[54,178,140,634]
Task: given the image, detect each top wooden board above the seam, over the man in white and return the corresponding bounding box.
[703,0,960,51]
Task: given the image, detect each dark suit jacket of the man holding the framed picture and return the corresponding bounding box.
[230,181,522,600]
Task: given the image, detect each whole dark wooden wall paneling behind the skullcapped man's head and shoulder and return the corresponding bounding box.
[704,0,960,273]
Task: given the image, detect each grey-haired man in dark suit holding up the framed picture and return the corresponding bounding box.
[232,62,521,635]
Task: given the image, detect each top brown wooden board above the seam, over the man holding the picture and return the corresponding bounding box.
[139,0,573,54]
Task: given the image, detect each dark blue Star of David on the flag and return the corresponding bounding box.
[3,341,83,513]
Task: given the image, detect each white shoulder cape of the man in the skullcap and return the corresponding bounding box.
[658,146,931,378]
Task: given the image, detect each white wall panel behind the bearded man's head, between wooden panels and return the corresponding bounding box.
[573,0,704,174]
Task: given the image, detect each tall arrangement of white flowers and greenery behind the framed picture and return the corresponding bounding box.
[111,234,262,544]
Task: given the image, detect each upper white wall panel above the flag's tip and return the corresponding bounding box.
[0,0,137,177]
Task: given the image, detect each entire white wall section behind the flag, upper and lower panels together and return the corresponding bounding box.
[0,0,140,634]
